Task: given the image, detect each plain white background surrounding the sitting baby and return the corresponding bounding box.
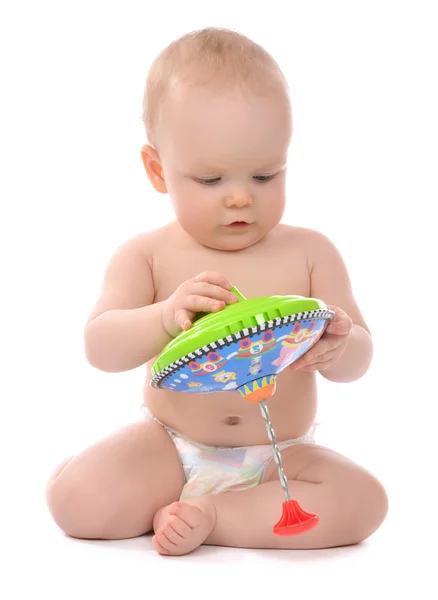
[0,0,438,598]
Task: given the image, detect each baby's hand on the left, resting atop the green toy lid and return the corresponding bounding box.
[162,271,239,337]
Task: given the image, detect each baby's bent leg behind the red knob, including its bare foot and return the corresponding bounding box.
[154,444,388,554]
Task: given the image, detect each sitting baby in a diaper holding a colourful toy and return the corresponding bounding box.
[47,28,388,555]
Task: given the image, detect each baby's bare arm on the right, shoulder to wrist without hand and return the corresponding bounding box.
[307,230,373,382]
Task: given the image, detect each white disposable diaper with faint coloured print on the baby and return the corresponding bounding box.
[142,406,315,500]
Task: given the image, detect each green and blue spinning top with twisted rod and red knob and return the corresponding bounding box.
[151,287,334,535]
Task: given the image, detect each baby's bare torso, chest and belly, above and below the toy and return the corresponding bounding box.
[144,224,317,446]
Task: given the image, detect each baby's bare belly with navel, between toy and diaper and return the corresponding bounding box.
[144,369,317,446]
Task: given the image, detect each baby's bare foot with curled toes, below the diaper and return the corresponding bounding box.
[152,499,216,556]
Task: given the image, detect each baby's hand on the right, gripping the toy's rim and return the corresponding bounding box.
[289,305,353,373]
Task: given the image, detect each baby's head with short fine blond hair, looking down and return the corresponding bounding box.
[142,28,292,250]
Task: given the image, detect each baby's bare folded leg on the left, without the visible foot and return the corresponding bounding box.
[47,420,184,539]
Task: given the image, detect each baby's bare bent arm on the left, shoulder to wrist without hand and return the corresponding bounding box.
[85,238,172,372]
